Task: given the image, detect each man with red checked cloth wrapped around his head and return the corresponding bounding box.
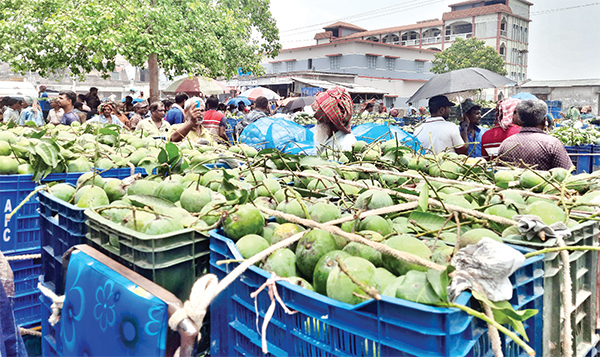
[312,87,356,154]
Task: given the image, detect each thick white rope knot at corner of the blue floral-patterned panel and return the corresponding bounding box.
[169,274,219,341]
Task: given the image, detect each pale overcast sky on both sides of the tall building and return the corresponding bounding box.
[271,0,600,80]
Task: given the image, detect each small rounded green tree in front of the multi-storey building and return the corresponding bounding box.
[431,37,507,76]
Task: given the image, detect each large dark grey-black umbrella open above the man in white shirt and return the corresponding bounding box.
[407,67,515,103]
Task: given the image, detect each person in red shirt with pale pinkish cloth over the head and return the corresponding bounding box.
[481,98,521,160]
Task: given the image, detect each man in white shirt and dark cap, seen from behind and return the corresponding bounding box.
[415,95,469,154]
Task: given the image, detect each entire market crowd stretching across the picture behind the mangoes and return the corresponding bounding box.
[1,86,593,170]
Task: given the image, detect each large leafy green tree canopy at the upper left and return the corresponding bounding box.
[0,0,281,92]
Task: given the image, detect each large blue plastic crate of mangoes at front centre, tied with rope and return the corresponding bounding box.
[210,231,543,357]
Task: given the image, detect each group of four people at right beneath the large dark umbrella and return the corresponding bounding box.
[415,95,573,170]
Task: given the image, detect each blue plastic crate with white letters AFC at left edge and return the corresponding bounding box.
[0,168,144,254]
